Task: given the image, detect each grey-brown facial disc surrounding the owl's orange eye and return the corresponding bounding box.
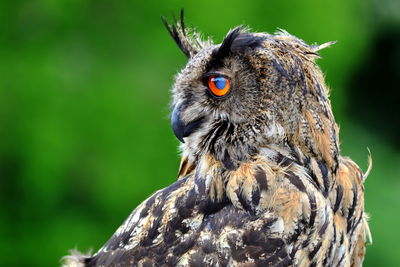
[173,37,263,132]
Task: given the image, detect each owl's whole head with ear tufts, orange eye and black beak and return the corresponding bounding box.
[164,11,338,173]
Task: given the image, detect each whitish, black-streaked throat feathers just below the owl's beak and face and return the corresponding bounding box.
[181,117,286,171]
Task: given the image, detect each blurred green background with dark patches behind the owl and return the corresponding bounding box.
[0,0,400,267]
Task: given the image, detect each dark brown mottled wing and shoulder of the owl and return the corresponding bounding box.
[86,163,291,266]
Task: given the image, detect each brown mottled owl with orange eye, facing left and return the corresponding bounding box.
[64,12,369,267]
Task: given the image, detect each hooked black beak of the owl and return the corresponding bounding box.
[171,105,204,143]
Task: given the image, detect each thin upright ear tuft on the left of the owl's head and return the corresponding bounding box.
[161,9,210,58]
